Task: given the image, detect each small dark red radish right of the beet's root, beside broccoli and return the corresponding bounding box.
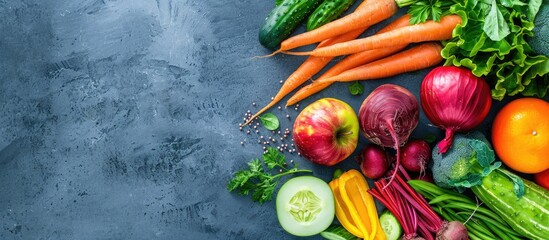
[402,139,431,174]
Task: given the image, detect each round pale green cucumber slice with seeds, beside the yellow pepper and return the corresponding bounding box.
[276,176,335,236]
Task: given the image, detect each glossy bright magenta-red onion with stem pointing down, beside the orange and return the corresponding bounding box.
[419,66,492,153]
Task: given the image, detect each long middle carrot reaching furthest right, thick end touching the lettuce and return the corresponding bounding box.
[285,15,461,57]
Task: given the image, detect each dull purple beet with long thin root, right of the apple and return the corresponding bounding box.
[358,84,419,185]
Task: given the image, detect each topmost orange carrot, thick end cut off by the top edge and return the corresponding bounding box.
[275,0,398,53]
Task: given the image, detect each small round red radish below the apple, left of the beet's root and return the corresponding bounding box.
[357,145,390,179]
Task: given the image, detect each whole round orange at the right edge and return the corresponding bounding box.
[492,98,549,173]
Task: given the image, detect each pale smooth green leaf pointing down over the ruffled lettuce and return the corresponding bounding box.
[482,0,510,41]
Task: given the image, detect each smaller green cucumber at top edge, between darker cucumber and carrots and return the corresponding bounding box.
[307,0,355,31]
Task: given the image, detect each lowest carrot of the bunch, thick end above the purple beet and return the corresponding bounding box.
[292,42,442,98]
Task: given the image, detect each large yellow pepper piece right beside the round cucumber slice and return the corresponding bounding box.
[329,169,386,240]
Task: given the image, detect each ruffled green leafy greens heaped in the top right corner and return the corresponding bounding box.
[396,0,549,100]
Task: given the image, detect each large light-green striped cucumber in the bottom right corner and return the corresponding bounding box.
[471,169,549,239]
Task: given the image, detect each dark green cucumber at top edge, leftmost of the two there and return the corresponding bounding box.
[259,0,321,50]
